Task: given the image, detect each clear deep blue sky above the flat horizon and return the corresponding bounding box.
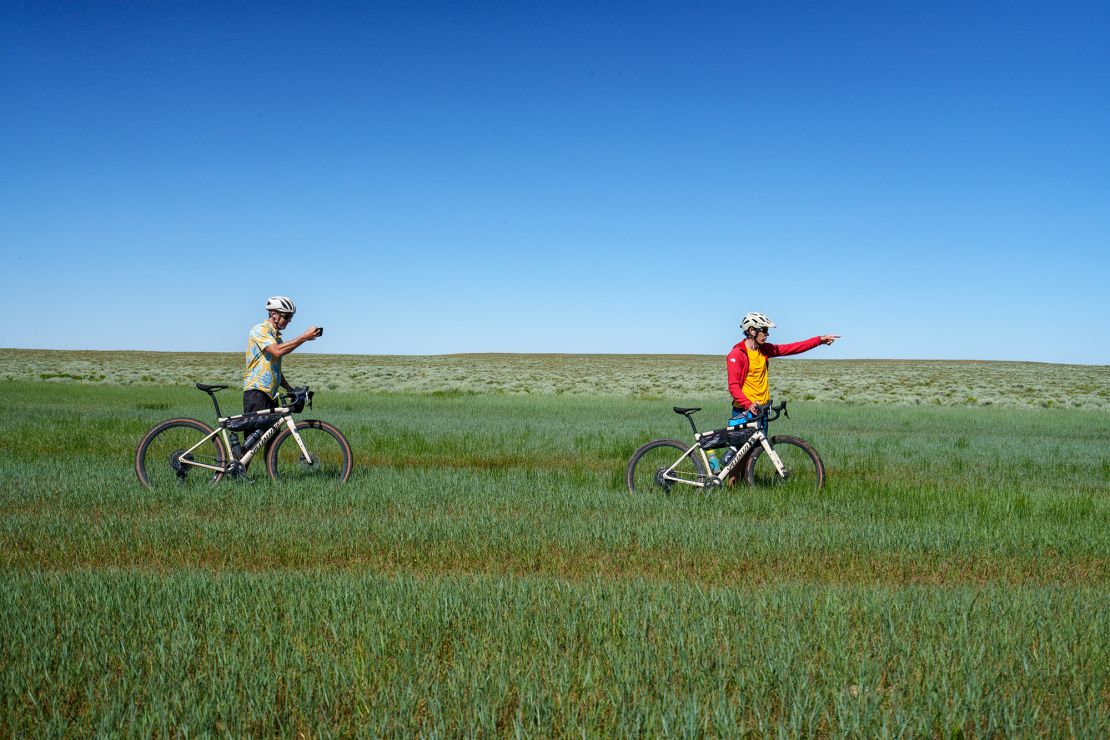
[0,2,1110,364]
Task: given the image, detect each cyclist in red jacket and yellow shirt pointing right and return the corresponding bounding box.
[728,312,840,426]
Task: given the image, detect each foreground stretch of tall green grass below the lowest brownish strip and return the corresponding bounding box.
[0,571,1110,737]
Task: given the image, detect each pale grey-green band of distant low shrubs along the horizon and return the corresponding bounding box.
[0,349,1110,409]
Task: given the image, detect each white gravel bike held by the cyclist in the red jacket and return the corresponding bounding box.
[625,401,825,494]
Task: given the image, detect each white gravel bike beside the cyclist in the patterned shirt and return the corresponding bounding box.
[135,383,353,488]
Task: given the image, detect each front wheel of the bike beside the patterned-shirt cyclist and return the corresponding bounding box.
[266,419,354,483]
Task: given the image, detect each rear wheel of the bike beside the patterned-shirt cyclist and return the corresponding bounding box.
[135,418,229,489]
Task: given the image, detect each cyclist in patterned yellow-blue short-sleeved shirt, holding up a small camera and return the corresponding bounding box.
[243,295,324,414]
